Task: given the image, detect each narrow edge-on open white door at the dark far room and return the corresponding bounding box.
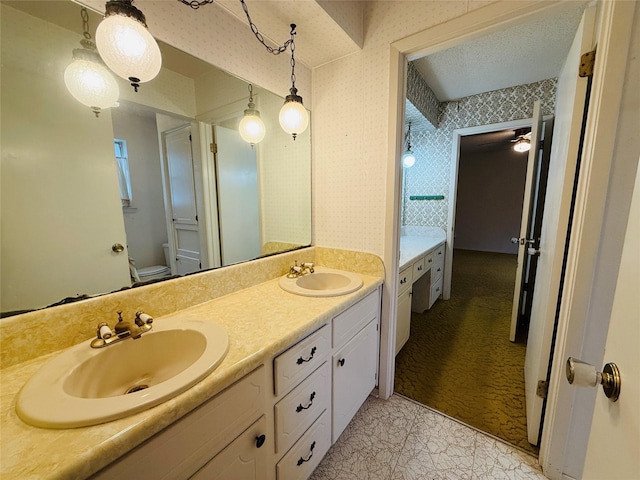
[509,100,542,342]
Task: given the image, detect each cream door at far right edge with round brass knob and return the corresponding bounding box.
[582,160,640,480]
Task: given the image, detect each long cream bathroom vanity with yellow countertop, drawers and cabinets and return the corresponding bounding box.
[1,248,382,480]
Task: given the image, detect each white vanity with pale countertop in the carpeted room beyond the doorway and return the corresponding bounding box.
[396,226,446,355]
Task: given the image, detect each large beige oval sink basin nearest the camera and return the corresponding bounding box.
[16,320,229,428]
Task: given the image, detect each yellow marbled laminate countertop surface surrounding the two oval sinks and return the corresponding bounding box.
[0,275,382,480]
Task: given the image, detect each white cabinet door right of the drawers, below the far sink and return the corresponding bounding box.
[332,321,378,442]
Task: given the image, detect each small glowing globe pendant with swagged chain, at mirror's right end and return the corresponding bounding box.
[180,0,309,140]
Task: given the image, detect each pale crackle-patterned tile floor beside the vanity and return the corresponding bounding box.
[310,395,546,480]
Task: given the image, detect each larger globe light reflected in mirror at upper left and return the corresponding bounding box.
[64,7,120,117]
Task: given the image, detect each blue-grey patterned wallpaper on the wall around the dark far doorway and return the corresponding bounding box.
[402,79,556,231]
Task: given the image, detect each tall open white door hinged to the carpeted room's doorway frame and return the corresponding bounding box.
[524,7,595,445]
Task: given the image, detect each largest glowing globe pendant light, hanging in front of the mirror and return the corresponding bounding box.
[96,0,162,92]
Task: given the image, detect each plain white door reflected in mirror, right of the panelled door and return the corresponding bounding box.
[214,125,261,265]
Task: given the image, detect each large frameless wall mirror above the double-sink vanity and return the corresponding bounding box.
[0,0,311,314]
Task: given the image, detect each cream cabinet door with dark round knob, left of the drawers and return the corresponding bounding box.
[190,417,273,480]
